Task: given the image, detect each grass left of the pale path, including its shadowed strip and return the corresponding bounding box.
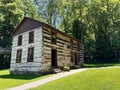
[0,70,51,90]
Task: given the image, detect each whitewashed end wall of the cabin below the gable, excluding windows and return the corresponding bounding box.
[10,27,43,74]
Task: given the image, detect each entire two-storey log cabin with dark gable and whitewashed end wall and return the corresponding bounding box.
[10,17,84,74]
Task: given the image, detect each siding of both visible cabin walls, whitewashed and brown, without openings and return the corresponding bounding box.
[10,27,83,74]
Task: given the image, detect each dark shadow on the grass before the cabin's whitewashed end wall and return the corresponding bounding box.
[0,74,44,80]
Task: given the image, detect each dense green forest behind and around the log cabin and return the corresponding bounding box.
[0,0,120,68]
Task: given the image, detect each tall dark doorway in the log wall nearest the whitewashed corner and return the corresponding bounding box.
[51,49,57,67]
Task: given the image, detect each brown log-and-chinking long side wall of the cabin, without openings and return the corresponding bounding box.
[42,27,83,71]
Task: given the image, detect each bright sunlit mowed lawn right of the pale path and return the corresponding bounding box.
[30,68,120,90]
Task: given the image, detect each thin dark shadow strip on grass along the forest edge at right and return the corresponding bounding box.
[84,63,120,68]
